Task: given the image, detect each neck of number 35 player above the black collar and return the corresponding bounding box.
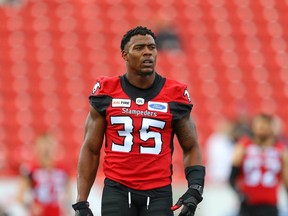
[125,72,155,89]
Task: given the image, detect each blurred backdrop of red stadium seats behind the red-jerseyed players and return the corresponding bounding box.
[0,0,288,216]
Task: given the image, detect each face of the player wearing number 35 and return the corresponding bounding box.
[122,34,157,75]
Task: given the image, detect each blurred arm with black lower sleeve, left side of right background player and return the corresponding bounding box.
[229,143,244,192]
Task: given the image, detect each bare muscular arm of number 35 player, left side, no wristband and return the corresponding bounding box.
[73,106,106,216]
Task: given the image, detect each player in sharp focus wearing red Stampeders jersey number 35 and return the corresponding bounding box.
[72,26,205,216]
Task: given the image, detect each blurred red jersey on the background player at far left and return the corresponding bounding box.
[25,163,68,216]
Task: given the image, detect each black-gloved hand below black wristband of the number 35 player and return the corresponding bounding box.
[171,188,203,216]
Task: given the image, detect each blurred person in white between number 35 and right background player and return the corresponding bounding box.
[201,116,237,216]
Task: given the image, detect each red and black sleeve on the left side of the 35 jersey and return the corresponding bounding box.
[89,77,112,117]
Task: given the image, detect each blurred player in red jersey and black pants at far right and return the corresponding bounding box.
[230,114,288,216]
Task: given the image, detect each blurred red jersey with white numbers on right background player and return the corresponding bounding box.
[240,139,284,205]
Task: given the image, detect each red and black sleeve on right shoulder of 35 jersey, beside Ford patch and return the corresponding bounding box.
[169,85,193,120]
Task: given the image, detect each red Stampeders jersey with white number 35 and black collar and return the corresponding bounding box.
[90,75,192,190]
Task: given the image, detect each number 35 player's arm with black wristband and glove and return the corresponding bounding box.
[171,113,205,216]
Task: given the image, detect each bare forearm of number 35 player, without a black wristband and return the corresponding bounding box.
[77,148,100,202]
